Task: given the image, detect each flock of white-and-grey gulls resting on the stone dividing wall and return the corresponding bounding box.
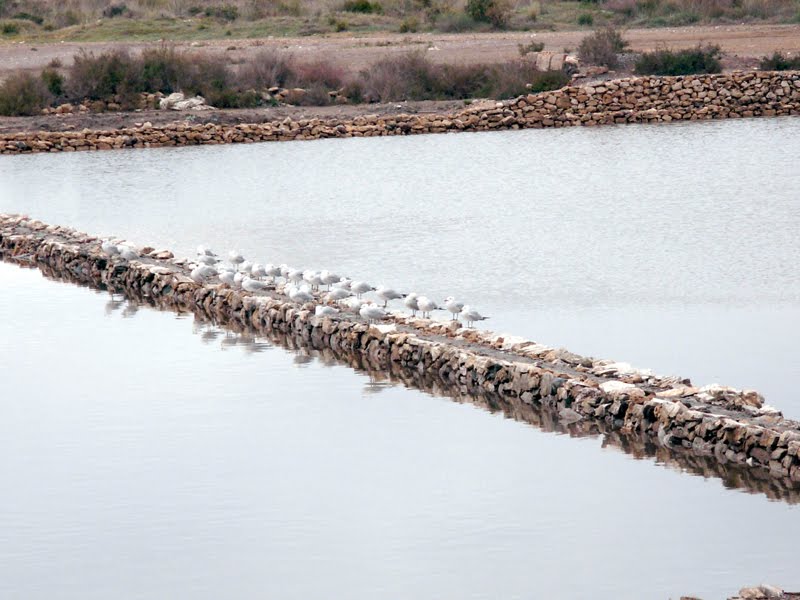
[101,240,489,327]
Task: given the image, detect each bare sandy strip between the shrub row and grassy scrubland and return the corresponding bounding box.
[0,25,800,78]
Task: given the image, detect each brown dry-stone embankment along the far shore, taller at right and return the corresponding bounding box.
[0,71,800,154]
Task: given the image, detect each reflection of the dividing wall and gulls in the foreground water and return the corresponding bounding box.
[14,258,800,504]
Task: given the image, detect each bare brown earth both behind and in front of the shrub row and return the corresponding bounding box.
[0,25,800,133]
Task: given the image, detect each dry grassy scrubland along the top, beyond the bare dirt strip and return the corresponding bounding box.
[0,0,800,41]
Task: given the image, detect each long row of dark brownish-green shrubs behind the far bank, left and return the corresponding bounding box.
[0,46,569,115]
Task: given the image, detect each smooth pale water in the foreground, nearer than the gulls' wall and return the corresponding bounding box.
[0,263,800,600]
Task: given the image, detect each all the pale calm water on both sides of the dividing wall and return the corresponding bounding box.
[0,119,800,599]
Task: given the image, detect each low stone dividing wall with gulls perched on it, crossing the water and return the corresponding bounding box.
[0,215,800,489]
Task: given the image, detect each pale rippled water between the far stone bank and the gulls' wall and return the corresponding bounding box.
[0,118,800,418]
